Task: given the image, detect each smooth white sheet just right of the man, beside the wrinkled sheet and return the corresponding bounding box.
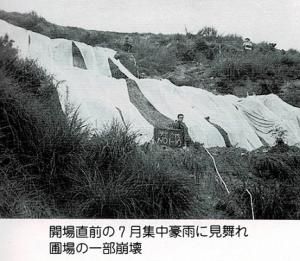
[133,80,262,150]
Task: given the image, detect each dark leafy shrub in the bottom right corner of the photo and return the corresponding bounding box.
[223,179,300,219]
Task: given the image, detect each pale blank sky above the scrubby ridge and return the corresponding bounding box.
[0,0,300,50]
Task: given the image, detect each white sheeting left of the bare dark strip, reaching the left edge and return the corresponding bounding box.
[0,20,153,142]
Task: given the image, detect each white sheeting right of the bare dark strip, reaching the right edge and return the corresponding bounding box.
[119,53,300,150]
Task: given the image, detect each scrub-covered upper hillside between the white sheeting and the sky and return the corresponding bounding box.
[0,11,300,107]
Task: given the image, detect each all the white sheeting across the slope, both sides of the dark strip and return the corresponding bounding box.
[0,20,300,150]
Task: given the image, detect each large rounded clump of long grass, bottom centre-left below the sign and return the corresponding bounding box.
[69,125,194,218]
